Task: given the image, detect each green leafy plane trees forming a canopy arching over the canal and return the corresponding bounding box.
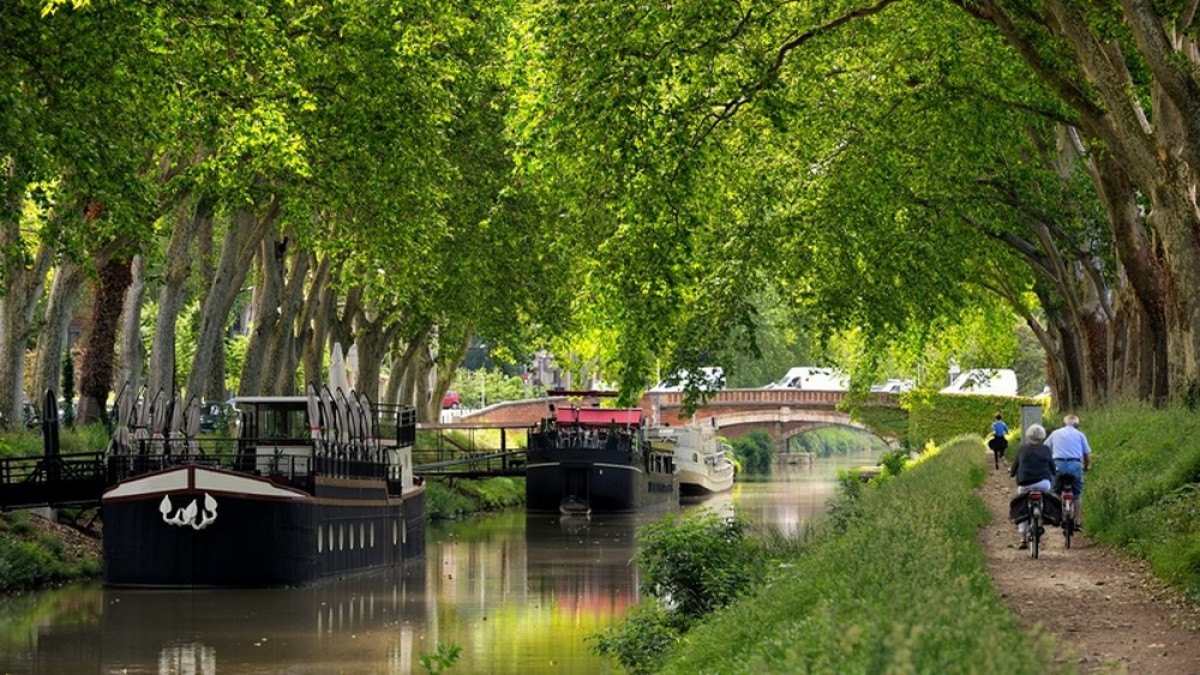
[0,0,1200,416]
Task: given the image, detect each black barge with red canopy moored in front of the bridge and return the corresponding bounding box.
[526,407,679,513]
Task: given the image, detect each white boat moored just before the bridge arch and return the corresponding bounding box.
[646,423,733,497]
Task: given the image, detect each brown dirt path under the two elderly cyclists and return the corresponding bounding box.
[979,453,1200,675]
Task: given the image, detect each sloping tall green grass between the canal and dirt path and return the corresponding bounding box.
[664,438,1052,674]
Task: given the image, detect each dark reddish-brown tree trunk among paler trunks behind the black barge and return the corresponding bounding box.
[77,256,133,426]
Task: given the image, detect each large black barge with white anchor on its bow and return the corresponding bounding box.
[102,387,425,587]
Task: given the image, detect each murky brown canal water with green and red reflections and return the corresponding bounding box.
[0,449,874,675]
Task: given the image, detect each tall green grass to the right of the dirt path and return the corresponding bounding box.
[1080,404,1200,602]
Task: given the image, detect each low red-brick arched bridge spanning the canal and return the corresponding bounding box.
[462,389,899,450]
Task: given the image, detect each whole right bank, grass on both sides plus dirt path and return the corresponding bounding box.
[664,405,1200,674]
